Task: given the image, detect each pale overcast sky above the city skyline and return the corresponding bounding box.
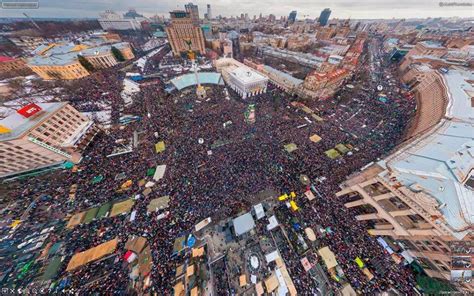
[0,0,474,19]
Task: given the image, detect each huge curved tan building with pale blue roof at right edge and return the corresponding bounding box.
[337,65,474,292]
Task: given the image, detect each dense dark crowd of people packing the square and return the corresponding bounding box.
[3,37,414,295]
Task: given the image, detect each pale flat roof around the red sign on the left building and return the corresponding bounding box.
[0,102,67,141]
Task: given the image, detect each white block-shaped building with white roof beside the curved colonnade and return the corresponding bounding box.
[214,58,268,99]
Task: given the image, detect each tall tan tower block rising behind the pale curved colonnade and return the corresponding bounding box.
[166,10,205,56]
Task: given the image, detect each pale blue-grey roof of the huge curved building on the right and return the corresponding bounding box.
[379,69,474,238]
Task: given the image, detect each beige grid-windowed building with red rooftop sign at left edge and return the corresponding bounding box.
[0,102,99,177]
